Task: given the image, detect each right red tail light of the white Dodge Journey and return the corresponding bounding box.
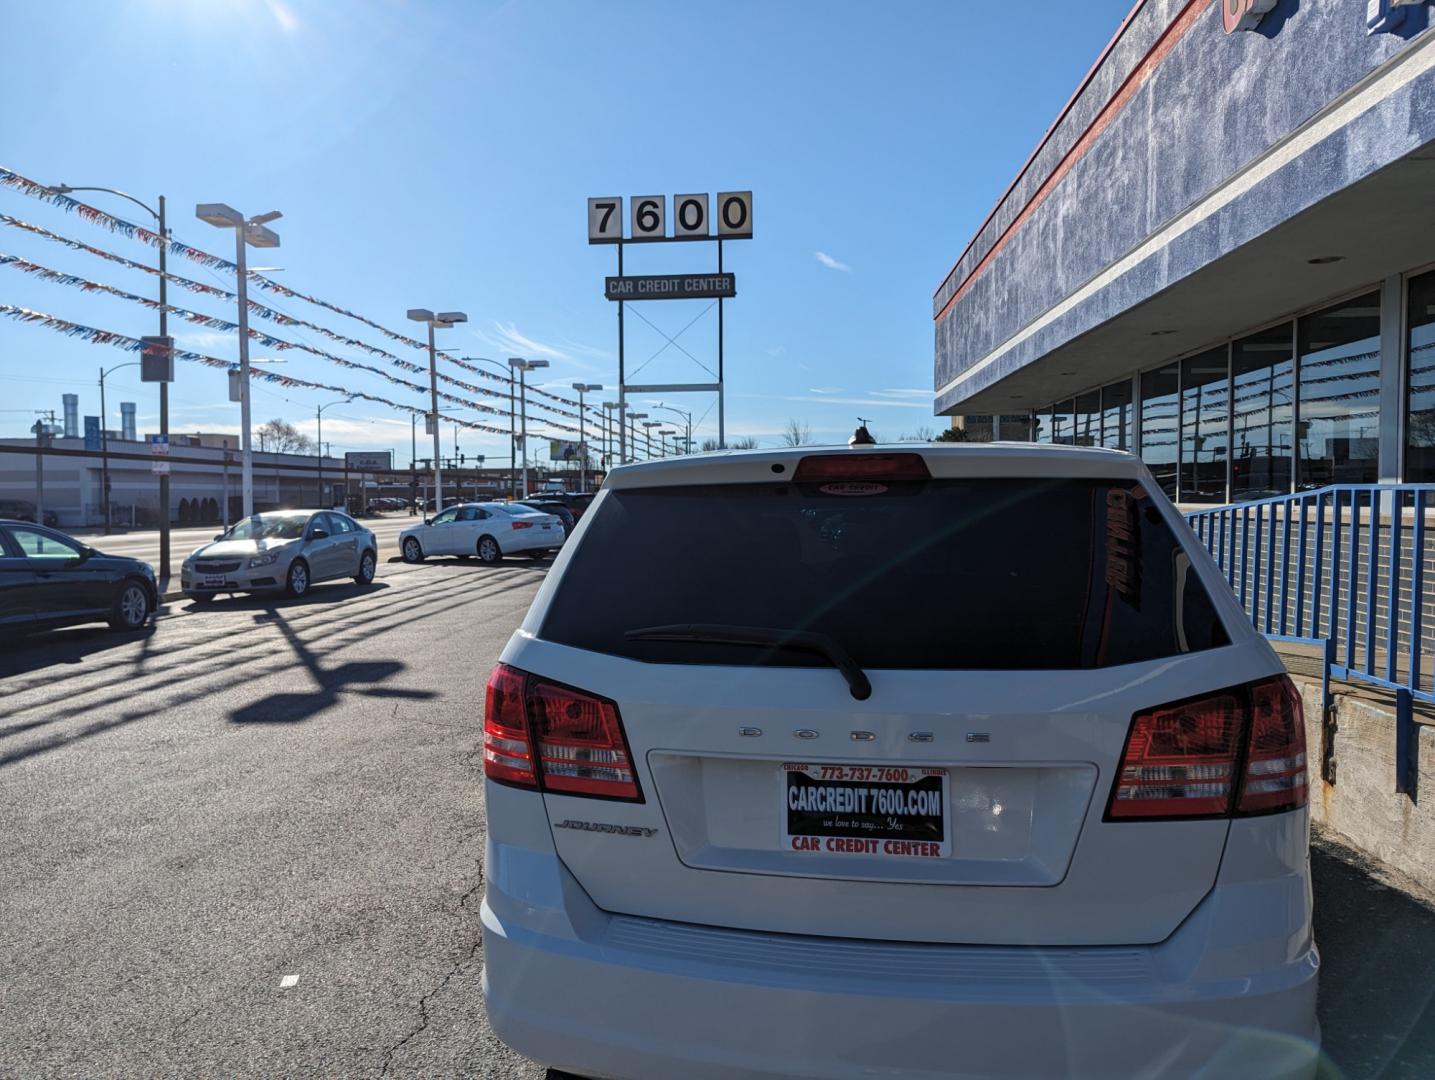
[1106,676,1306,820]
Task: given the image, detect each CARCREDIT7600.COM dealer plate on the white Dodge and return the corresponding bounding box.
[782,763,951,859]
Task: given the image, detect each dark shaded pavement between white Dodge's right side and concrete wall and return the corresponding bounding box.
[1310,838,1435,1080]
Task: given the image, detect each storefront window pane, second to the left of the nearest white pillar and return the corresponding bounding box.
[1231,323,1296,502]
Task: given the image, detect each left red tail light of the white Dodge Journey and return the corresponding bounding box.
[484,664,643,802]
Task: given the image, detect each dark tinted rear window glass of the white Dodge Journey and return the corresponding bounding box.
[540,479,1228,670]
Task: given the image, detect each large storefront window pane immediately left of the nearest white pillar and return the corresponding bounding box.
[1296,293,1380,491]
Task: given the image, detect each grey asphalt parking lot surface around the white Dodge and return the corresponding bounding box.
[0,559,1435,1077]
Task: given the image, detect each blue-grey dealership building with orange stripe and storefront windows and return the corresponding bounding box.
[933,0,1435,503]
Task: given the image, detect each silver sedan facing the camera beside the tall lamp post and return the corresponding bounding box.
[179,511,379,601]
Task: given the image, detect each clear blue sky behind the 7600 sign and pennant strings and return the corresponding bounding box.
[0,0,1129,462]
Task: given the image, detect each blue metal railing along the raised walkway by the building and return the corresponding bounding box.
[1185,483,1435,795]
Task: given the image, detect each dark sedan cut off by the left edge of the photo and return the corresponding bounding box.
[0,519,159,633]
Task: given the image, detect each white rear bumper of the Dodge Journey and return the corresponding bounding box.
[482,849,1319,1080]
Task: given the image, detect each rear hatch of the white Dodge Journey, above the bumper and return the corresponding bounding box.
[491,453,1276,945]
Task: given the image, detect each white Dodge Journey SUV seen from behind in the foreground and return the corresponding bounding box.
[482,443,1319,1079]
